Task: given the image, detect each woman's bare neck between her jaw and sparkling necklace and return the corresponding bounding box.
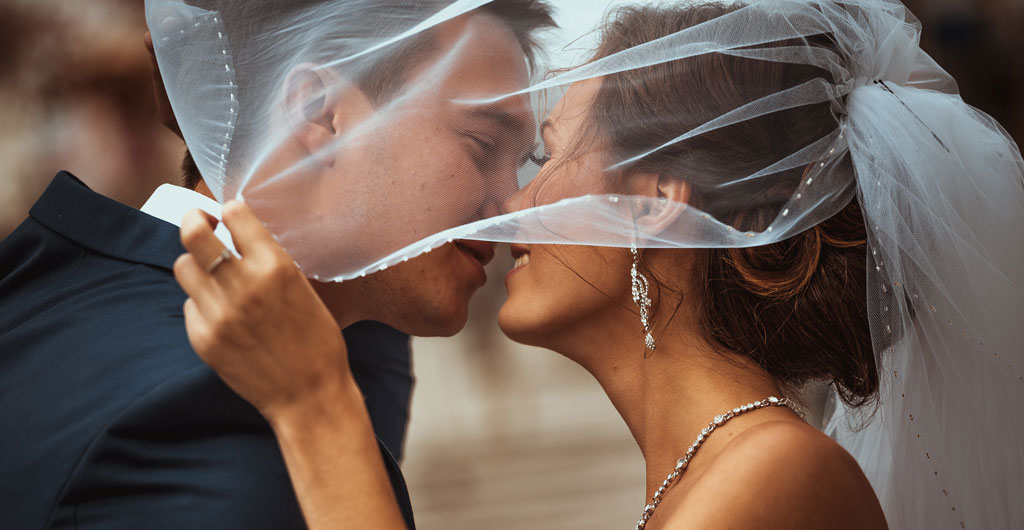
[563,304,781,498]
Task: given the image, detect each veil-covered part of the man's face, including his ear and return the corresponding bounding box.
[231,13,535,277]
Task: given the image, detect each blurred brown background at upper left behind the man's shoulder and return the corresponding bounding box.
[0,0,183,236]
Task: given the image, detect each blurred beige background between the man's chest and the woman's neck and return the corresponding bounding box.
[402,263,645,530]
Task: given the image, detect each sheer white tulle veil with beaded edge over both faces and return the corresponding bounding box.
[146,0,1024,529]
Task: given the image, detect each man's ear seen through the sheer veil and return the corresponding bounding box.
[283,63,373,167]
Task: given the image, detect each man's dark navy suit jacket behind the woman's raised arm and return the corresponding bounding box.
[0,173,413,530]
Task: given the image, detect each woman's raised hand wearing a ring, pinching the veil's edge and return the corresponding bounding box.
[174,202,354,424]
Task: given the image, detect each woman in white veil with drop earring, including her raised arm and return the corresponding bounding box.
[179,0,1024,529]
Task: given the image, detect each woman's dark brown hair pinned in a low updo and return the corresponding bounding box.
[577,4,879,406]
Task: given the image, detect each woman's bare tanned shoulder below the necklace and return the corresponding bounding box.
[662,422,887,530]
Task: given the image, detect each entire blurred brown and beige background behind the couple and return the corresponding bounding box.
[0,0,1024,530]
